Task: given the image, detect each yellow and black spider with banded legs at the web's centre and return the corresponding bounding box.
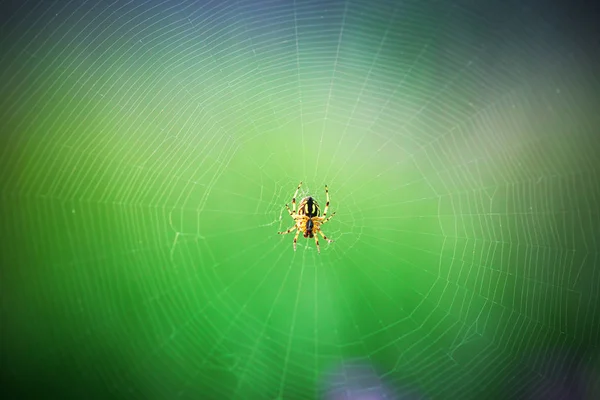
[277,182,335,253]
